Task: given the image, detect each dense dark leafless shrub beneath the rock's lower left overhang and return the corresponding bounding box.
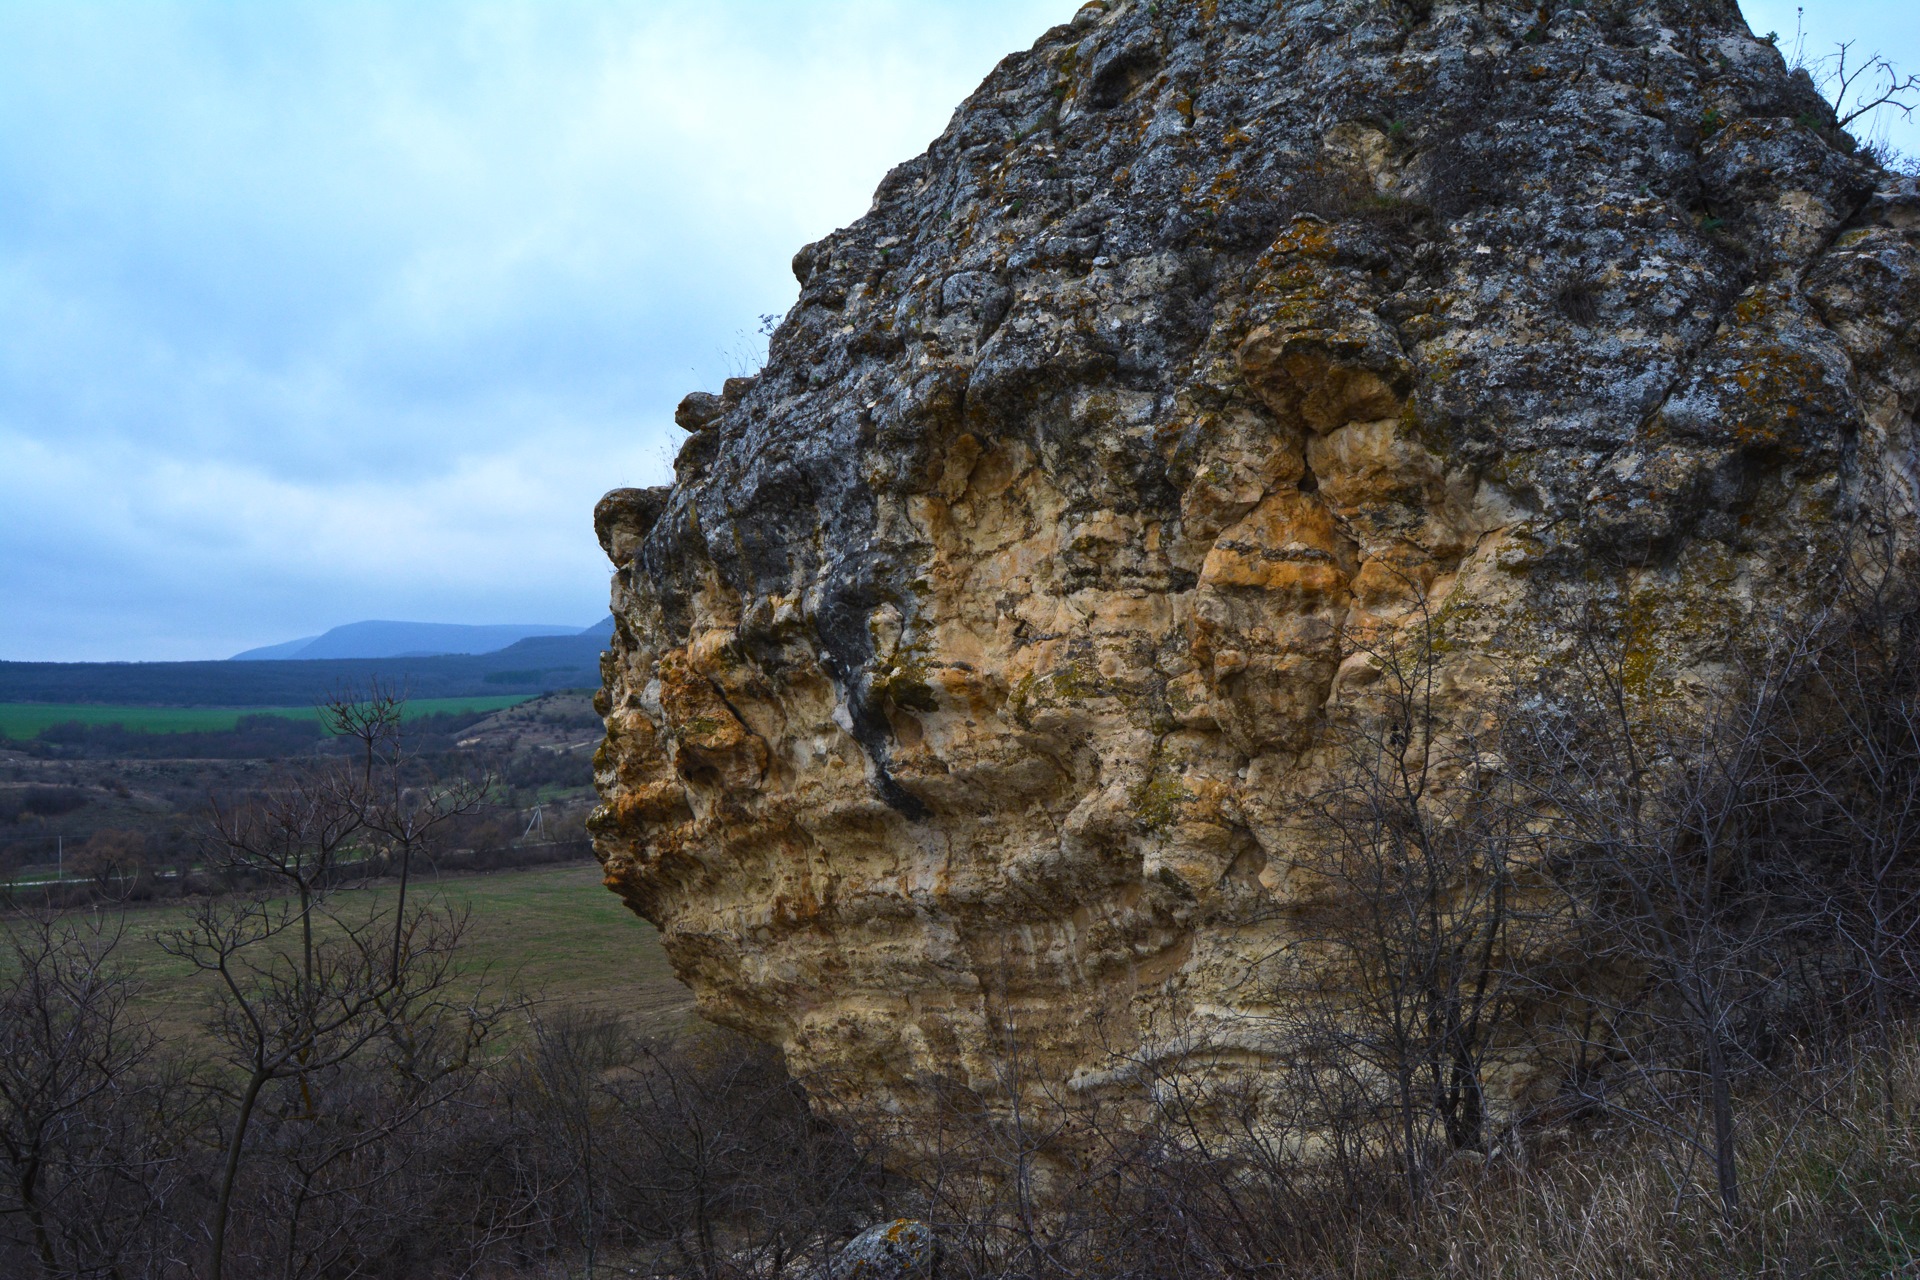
[438,1007,879,1278]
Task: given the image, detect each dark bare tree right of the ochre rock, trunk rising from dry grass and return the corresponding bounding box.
[1507,606,1809,1222]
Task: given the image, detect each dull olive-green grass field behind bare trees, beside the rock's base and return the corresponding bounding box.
[84,864,693,1036]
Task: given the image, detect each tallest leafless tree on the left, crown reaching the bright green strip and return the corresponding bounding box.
[159,689,501,1280]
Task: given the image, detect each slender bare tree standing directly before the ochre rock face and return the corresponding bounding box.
[1263,604,1530,1201]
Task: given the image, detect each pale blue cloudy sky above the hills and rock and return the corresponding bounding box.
[0,0,1920,660]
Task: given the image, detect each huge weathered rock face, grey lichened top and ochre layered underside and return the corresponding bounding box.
[595,0,1920,1109]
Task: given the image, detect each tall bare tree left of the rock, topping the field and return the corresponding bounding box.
[159,689,499,1280]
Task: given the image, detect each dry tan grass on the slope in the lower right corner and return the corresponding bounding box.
[1315,1040,1920,1280]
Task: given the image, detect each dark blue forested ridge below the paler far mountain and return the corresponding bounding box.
[0,616,612,706]
